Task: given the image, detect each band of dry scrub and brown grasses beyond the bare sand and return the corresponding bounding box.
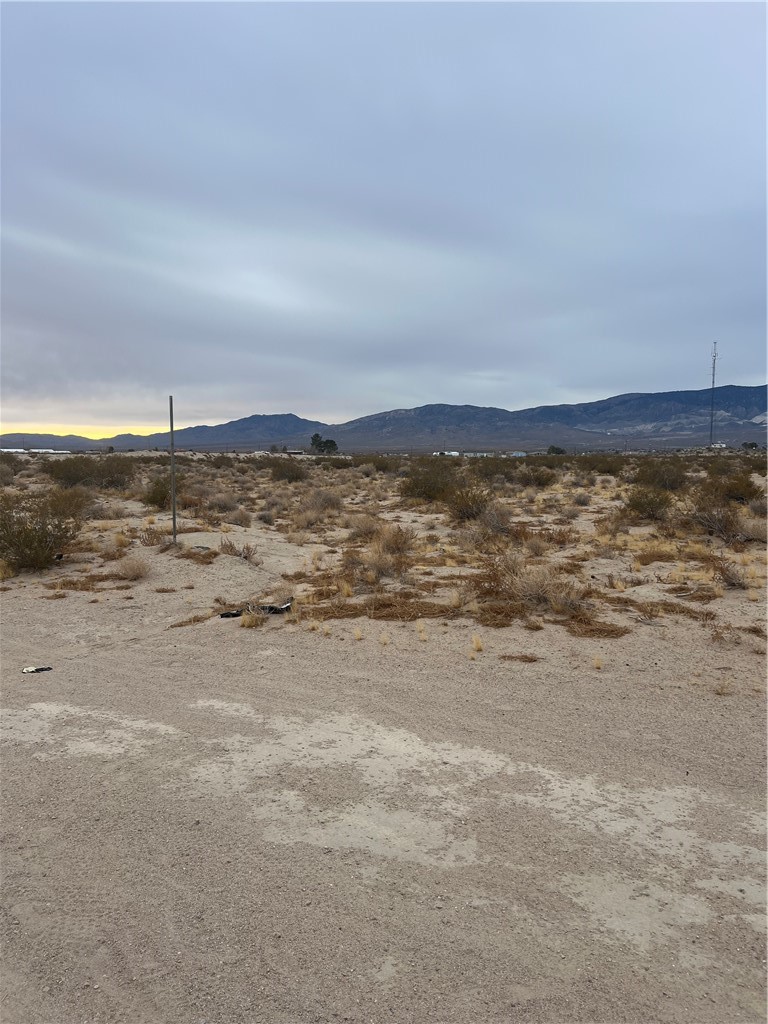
[0,453,766,639]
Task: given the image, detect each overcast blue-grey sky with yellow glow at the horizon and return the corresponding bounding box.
[2,3,766,433]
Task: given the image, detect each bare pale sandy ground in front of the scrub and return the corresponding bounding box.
[0,493,766,1024]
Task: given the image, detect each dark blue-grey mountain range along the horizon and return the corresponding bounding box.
[0,385,768,452]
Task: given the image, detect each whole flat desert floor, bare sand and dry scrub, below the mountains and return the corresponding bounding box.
[0,455,766,1024]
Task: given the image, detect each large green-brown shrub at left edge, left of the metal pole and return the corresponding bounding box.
[0,494,82,570]
